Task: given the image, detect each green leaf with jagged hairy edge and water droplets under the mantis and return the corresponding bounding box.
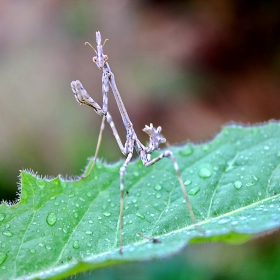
[0,122,280,279]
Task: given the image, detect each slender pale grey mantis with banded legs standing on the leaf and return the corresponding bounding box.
[71,31,196,253]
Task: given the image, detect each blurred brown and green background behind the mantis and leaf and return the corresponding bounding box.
[0,0,280,279]
